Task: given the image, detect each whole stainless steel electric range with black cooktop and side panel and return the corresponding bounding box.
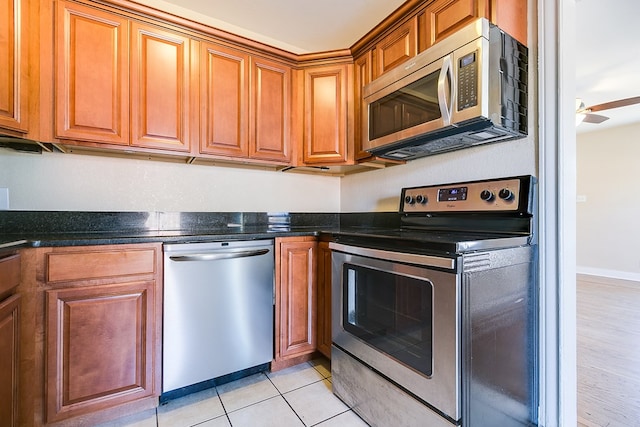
[330,176,538,427]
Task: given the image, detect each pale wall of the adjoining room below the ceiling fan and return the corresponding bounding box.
[576,123,640,281]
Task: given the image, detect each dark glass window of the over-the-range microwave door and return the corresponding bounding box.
[369,70,442,140]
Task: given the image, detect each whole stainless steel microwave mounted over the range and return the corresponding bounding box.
[362,18,528,160]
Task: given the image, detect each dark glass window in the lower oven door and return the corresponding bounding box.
[343,264,433,376]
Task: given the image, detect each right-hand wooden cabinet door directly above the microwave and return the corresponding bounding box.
[418,0,488,52]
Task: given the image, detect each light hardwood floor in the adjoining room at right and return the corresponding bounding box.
[577,274,640,427]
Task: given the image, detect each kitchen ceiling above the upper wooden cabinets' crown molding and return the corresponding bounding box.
[141,0,405,54]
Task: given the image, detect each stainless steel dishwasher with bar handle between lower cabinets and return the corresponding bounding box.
[160,240,274,402]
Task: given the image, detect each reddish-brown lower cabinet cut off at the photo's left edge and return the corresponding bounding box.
[0,254,20,427]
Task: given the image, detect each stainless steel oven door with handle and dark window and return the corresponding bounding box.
[330,243,461,421]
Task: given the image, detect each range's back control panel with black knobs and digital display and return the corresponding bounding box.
[400,176,532,213]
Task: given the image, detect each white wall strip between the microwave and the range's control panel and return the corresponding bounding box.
[340,136,537,212]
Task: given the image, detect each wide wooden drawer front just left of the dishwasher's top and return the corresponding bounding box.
[47,249,156,282]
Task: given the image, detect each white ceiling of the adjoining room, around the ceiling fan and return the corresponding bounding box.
[576,0,640,133]
